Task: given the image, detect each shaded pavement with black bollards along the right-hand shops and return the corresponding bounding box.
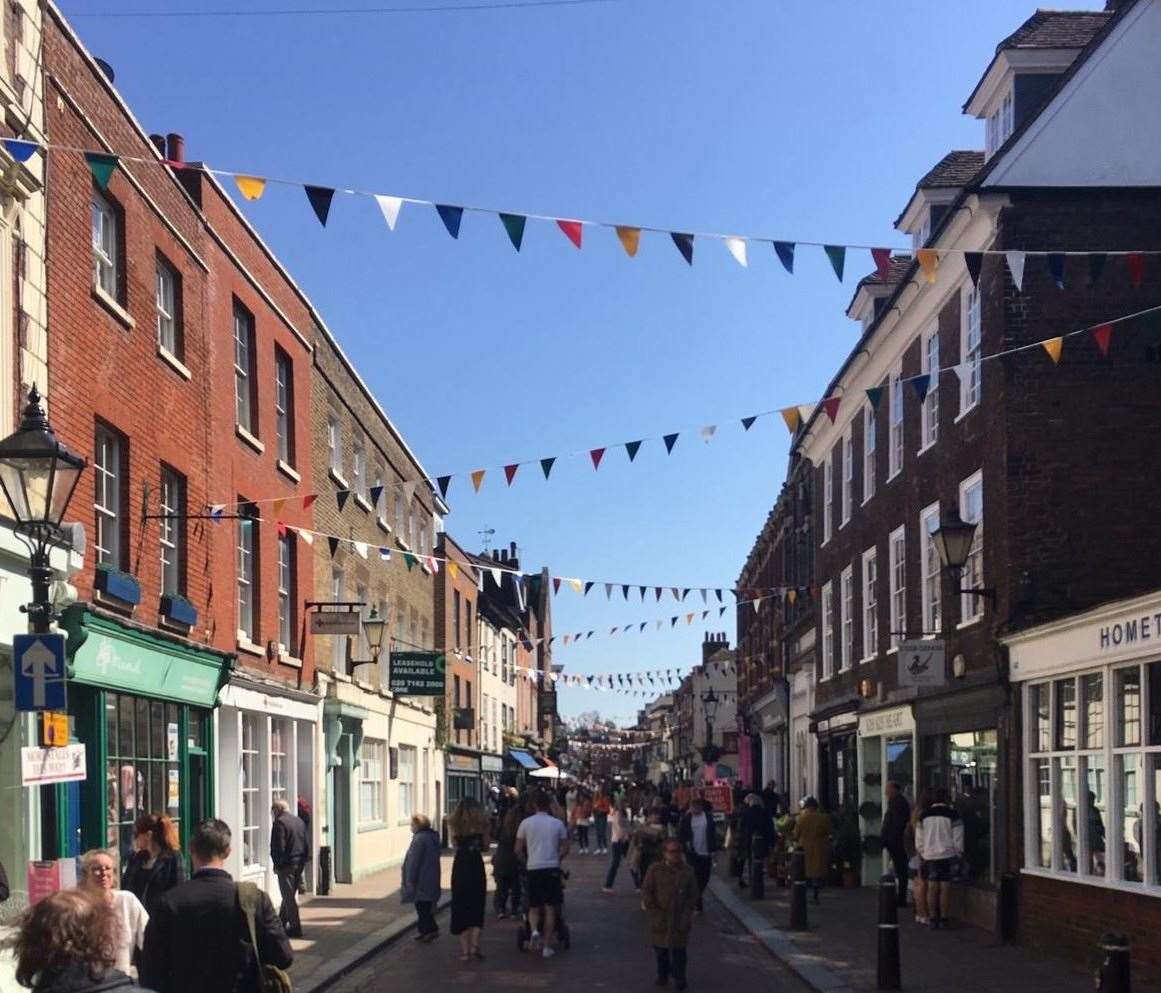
[709,873,1096,993]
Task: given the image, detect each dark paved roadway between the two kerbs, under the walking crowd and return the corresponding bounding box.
[330,856,807,993]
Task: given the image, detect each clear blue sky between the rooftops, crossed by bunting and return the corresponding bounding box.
[67,0,1103,720]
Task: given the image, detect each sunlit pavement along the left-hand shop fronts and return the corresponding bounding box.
[290,855,452,993]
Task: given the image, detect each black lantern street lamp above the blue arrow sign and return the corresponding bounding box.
[0,386,88,634]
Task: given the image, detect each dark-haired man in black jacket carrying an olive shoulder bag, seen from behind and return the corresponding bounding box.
[139,818,294,993]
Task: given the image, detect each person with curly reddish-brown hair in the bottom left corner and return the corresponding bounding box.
[12,888,154,993]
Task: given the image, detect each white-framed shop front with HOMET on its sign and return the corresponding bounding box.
[1003,591,1161,978]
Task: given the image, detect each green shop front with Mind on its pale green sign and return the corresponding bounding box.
[51,604,233,858]
